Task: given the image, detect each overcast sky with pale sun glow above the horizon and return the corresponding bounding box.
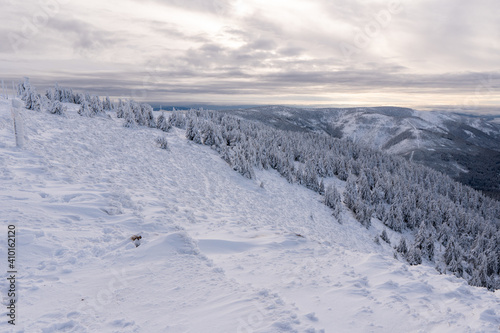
[0,0,500,108]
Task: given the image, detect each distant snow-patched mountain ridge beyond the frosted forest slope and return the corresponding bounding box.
[223,106,500,199]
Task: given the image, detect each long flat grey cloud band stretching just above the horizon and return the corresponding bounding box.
[6,68,500,100]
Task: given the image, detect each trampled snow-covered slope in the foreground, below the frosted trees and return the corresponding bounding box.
[0,100,500,332]
